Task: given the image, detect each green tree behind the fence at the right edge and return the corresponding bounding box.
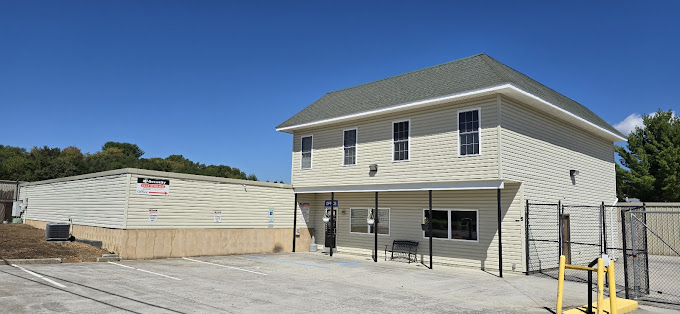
[615,110,680,202]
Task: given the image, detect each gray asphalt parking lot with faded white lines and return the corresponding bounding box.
[0,253,664,313]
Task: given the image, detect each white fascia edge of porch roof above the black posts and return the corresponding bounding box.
[293,180,505,194]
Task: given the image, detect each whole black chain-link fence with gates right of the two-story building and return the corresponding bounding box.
[525,202,680,308]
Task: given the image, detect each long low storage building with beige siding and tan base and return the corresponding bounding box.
[20,168,311,259]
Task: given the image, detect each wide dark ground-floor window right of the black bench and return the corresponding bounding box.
[423,209,479,241]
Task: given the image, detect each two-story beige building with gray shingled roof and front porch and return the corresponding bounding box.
[277,54,625,271]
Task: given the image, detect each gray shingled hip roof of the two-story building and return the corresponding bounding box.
[277,54,625,137]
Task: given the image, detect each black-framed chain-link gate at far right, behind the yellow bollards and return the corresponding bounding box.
[621,206,680,305]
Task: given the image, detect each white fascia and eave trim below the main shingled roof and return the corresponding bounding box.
[276,83,627,142]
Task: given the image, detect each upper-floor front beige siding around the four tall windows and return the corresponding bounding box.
[292,97,499,188]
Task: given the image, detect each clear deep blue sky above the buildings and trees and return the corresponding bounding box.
[0,1,680,182]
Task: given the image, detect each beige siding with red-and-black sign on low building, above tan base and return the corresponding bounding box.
[127,174,305,228]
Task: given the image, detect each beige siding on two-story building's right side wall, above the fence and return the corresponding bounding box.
[501,98,616,205]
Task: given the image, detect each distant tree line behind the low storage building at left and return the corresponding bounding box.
[0,142,270,183]
